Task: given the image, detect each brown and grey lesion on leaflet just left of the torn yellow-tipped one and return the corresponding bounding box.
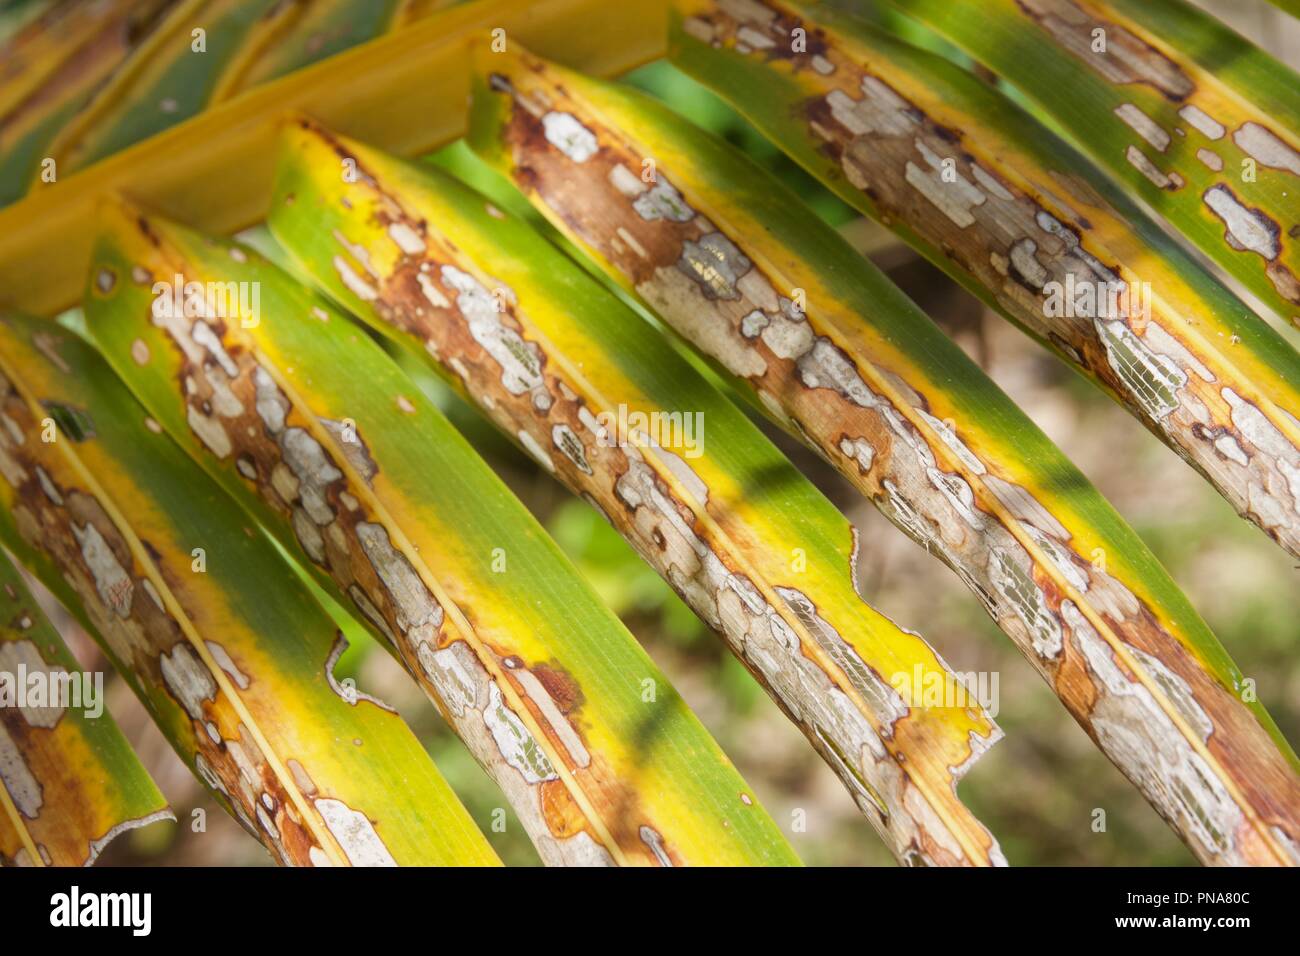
[120,217,644,864]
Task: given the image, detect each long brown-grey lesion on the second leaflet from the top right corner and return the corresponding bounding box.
[691,0,1300,567]
